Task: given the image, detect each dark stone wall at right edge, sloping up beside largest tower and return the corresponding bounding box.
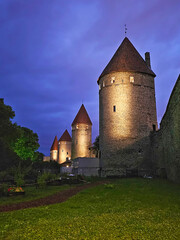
[151,77,180,182]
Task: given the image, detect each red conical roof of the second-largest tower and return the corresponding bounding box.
[72,104,92,126]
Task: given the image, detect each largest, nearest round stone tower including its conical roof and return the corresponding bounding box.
[98,37,157,176]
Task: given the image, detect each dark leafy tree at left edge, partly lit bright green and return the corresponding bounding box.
[0,99,42,170]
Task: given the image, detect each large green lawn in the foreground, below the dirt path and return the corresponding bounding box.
[0,179,180,240]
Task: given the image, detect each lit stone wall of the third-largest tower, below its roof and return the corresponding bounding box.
[58,141,71,164]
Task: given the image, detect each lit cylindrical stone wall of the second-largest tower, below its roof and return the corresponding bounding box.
[71,123,92,159]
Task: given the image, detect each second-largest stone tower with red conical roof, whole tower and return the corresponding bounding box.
[71,104,92,159]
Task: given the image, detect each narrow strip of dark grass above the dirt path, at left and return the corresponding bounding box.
[0,185,69,205]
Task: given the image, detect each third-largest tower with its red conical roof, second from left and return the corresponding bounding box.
[58,129,72,164]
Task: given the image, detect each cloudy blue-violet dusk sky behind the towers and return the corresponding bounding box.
[0,0,180,155]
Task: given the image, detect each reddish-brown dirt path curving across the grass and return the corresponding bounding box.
[0,181,105,212]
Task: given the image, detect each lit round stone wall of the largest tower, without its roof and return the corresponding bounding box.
[99,72,157,175]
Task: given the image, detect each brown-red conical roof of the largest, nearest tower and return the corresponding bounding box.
[98,37,156,81]
